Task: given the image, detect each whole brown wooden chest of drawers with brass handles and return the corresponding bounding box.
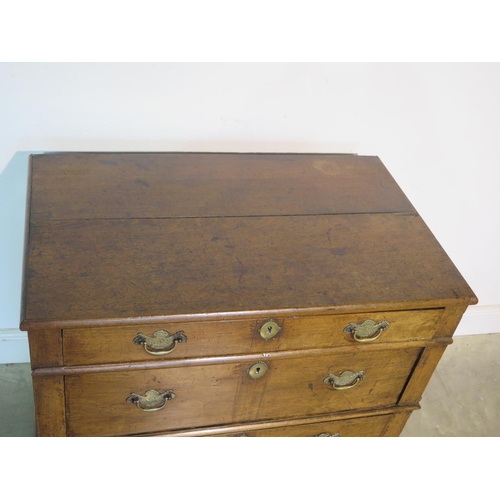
[21,153,477,436]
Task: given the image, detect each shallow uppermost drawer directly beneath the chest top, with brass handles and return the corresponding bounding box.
[63,309,443,366]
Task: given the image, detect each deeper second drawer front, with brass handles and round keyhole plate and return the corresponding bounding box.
[65,348,420,436]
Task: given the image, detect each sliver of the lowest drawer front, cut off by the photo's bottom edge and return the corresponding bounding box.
[225,415,392,437]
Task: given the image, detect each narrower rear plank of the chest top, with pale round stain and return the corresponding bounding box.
[31,153,415,222]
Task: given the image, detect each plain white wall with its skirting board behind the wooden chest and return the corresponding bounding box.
[0,63,500,363]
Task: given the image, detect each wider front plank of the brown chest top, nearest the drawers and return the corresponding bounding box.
[22,214,475,328]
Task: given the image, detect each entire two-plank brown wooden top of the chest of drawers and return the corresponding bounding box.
[21,153,477,329]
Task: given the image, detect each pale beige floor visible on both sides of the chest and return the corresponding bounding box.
[0,334,500,437]
